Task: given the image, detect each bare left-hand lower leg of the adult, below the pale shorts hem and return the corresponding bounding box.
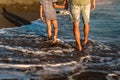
[73,22,82,51]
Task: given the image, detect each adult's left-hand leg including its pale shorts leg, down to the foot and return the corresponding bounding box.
[70,4,82,51]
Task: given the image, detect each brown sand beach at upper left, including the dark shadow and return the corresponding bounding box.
[0,1,39,28]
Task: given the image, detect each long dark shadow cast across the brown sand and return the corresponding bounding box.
[2,7,31,26]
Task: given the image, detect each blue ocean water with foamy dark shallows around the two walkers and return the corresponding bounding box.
[0,0,120,80]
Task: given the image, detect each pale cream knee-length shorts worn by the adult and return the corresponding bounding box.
[70,4,90,24]
